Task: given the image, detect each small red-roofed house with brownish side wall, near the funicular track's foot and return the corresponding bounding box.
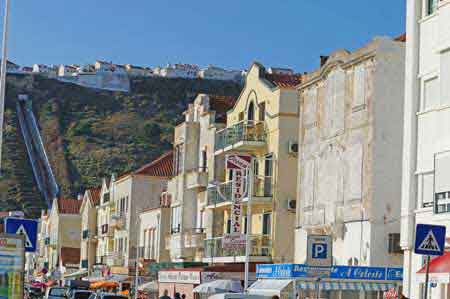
[46,198,82,275]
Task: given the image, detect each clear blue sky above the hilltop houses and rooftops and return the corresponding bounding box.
[2,0,405,72]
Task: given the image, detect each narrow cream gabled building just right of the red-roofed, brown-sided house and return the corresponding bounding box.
[80,187,101,272]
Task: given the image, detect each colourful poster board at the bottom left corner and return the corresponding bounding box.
[0,234,25,299]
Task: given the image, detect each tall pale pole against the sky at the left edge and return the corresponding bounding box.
[0,0,9,175]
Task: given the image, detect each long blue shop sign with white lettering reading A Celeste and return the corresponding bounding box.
[256,264,403,281]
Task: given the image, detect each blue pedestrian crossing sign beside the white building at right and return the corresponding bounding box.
[414,224,445,255]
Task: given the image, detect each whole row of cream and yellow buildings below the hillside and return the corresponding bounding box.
[32,32,405,298]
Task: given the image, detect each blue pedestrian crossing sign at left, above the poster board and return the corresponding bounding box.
[5,217,38,252]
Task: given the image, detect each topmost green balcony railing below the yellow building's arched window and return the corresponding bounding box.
[214,120,266,151]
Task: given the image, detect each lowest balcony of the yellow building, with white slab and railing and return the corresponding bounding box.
[203,235,272,263]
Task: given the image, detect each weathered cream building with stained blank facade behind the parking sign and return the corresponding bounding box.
[295,38,405,267]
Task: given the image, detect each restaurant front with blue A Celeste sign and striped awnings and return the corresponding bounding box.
[249,264,403,299]
